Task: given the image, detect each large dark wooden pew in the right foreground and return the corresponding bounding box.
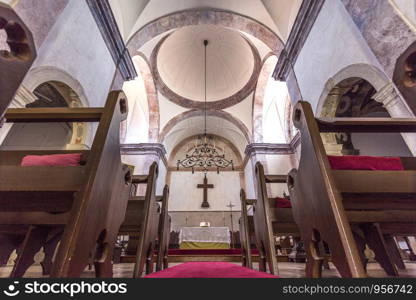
[288,101,416,277]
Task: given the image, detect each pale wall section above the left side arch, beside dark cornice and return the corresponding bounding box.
[32,1,115,106]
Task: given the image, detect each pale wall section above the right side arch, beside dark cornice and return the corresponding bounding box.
[295,0,382,109]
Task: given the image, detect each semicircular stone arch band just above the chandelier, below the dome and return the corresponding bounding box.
[159,109,251,144]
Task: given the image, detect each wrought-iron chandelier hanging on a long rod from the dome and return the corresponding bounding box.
[177,40,234,173]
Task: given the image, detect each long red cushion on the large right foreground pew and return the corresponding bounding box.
[328,155,404,171]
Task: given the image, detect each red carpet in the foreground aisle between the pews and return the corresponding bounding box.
[145,262,278,278]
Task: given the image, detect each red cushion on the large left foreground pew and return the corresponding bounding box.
[21,153,82,167]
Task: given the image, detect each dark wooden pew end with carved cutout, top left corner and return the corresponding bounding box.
[0,3,36,118]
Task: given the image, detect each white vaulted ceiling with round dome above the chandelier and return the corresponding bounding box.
[109,0,302,154]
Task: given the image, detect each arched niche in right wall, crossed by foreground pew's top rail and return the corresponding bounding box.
[316,65,410,156]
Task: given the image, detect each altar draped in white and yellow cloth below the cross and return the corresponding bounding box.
[179,227,231,249]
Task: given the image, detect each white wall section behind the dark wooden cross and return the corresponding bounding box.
[169,172,241,211]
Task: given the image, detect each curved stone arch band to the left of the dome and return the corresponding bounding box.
[135,52,160,143]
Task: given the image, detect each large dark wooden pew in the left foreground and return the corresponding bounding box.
[0,92,131,277]
